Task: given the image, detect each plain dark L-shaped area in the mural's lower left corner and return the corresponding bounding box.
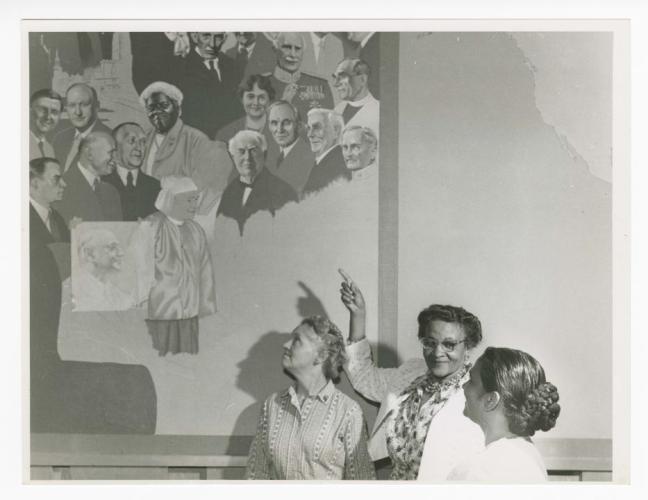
[30,238,157,434]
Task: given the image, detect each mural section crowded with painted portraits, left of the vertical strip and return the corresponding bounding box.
[29,32,379,435]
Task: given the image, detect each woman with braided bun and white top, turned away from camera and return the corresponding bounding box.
[448,347,560,483]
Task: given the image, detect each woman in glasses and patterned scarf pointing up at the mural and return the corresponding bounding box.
[340,270,484,481]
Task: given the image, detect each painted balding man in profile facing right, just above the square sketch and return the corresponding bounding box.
[54,132,123,223]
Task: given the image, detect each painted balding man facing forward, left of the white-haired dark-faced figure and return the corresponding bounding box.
[54,83,111,172]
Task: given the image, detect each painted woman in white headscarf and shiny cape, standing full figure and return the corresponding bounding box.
[146,176,216,356]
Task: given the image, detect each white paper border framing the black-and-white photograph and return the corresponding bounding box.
[1,1,648,498]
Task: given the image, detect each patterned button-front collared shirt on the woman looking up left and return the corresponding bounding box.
[246,381,375,480]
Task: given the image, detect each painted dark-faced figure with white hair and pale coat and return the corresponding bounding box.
[140,82,233,215]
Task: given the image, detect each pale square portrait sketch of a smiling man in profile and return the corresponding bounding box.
[72,222,153,311]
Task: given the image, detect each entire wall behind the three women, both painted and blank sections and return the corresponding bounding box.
[29,28,612,458]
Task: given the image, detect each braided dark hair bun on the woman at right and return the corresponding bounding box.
[511,382,560,436]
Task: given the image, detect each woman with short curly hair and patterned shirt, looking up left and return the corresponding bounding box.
[246,316,375,480]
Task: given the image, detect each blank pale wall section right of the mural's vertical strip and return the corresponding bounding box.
[398,33,612,437]
